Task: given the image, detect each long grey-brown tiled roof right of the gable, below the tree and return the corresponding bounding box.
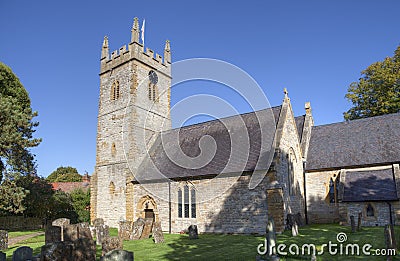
[306,113,400,170]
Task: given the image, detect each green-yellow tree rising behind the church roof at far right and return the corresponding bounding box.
[344,46,400,120]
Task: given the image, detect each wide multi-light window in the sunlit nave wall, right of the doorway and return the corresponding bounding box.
[178,184,197,218]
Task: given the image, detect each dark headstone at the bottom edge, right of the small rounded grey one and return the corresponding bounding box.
[40,241,74,261]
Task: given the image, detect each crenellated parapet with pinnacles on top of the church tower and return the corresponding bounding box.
[100,17,171,74]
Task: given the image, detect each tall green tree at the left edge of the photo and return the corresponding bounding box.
[0,62,41,181]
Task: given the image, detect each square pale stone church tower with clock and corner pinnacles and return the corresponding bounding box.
[91,18,171,227]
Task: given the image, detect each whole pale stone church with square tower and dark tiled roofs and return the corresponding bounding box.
[91,18,400,234]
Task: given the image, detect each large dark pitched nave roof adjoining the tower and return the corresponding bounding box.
[135,106,281,181]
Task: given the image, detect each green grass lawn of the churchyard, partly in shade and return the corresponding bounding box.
[1,225,400,261]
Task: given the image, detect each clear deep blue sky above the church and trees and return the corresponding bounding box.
[0,0,400,176]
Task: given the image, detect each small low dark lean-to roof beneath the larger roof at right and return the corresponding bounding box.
[342,169,397,202]
